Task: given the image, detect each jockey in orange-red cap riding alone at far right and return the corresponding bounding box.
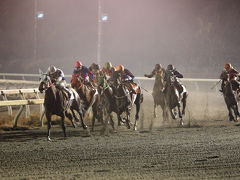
[219,63,240,93]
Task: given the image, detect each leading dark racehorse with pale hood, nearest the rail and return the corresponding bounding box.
[38,73,87,141]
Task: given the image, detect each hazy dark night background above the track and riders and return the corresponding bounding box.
[0,0,240,78]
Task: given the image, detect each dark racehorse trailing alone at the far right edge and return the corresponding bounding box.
[223,78,240,122]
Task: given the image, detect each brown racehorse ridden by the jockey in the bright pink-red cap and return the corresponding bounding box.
[71,77,102,131]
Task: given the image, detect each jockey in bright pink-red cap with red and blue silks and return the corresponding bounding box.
[71,61,94,87]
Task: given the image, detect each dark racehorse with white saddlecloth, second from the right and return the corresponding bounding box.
[166,76,188,126]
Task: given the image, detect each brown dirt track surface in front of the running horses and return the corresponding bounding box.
[0,119,240,179]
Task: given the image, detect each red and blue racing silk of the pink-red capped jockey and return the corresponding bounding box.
[72,66,94,83]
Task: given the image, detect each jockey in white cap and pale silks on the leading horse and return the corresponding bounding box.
[47,65,72,98]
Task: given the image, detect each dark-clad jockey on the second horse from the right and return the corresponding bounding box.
[163,64,183,93]
